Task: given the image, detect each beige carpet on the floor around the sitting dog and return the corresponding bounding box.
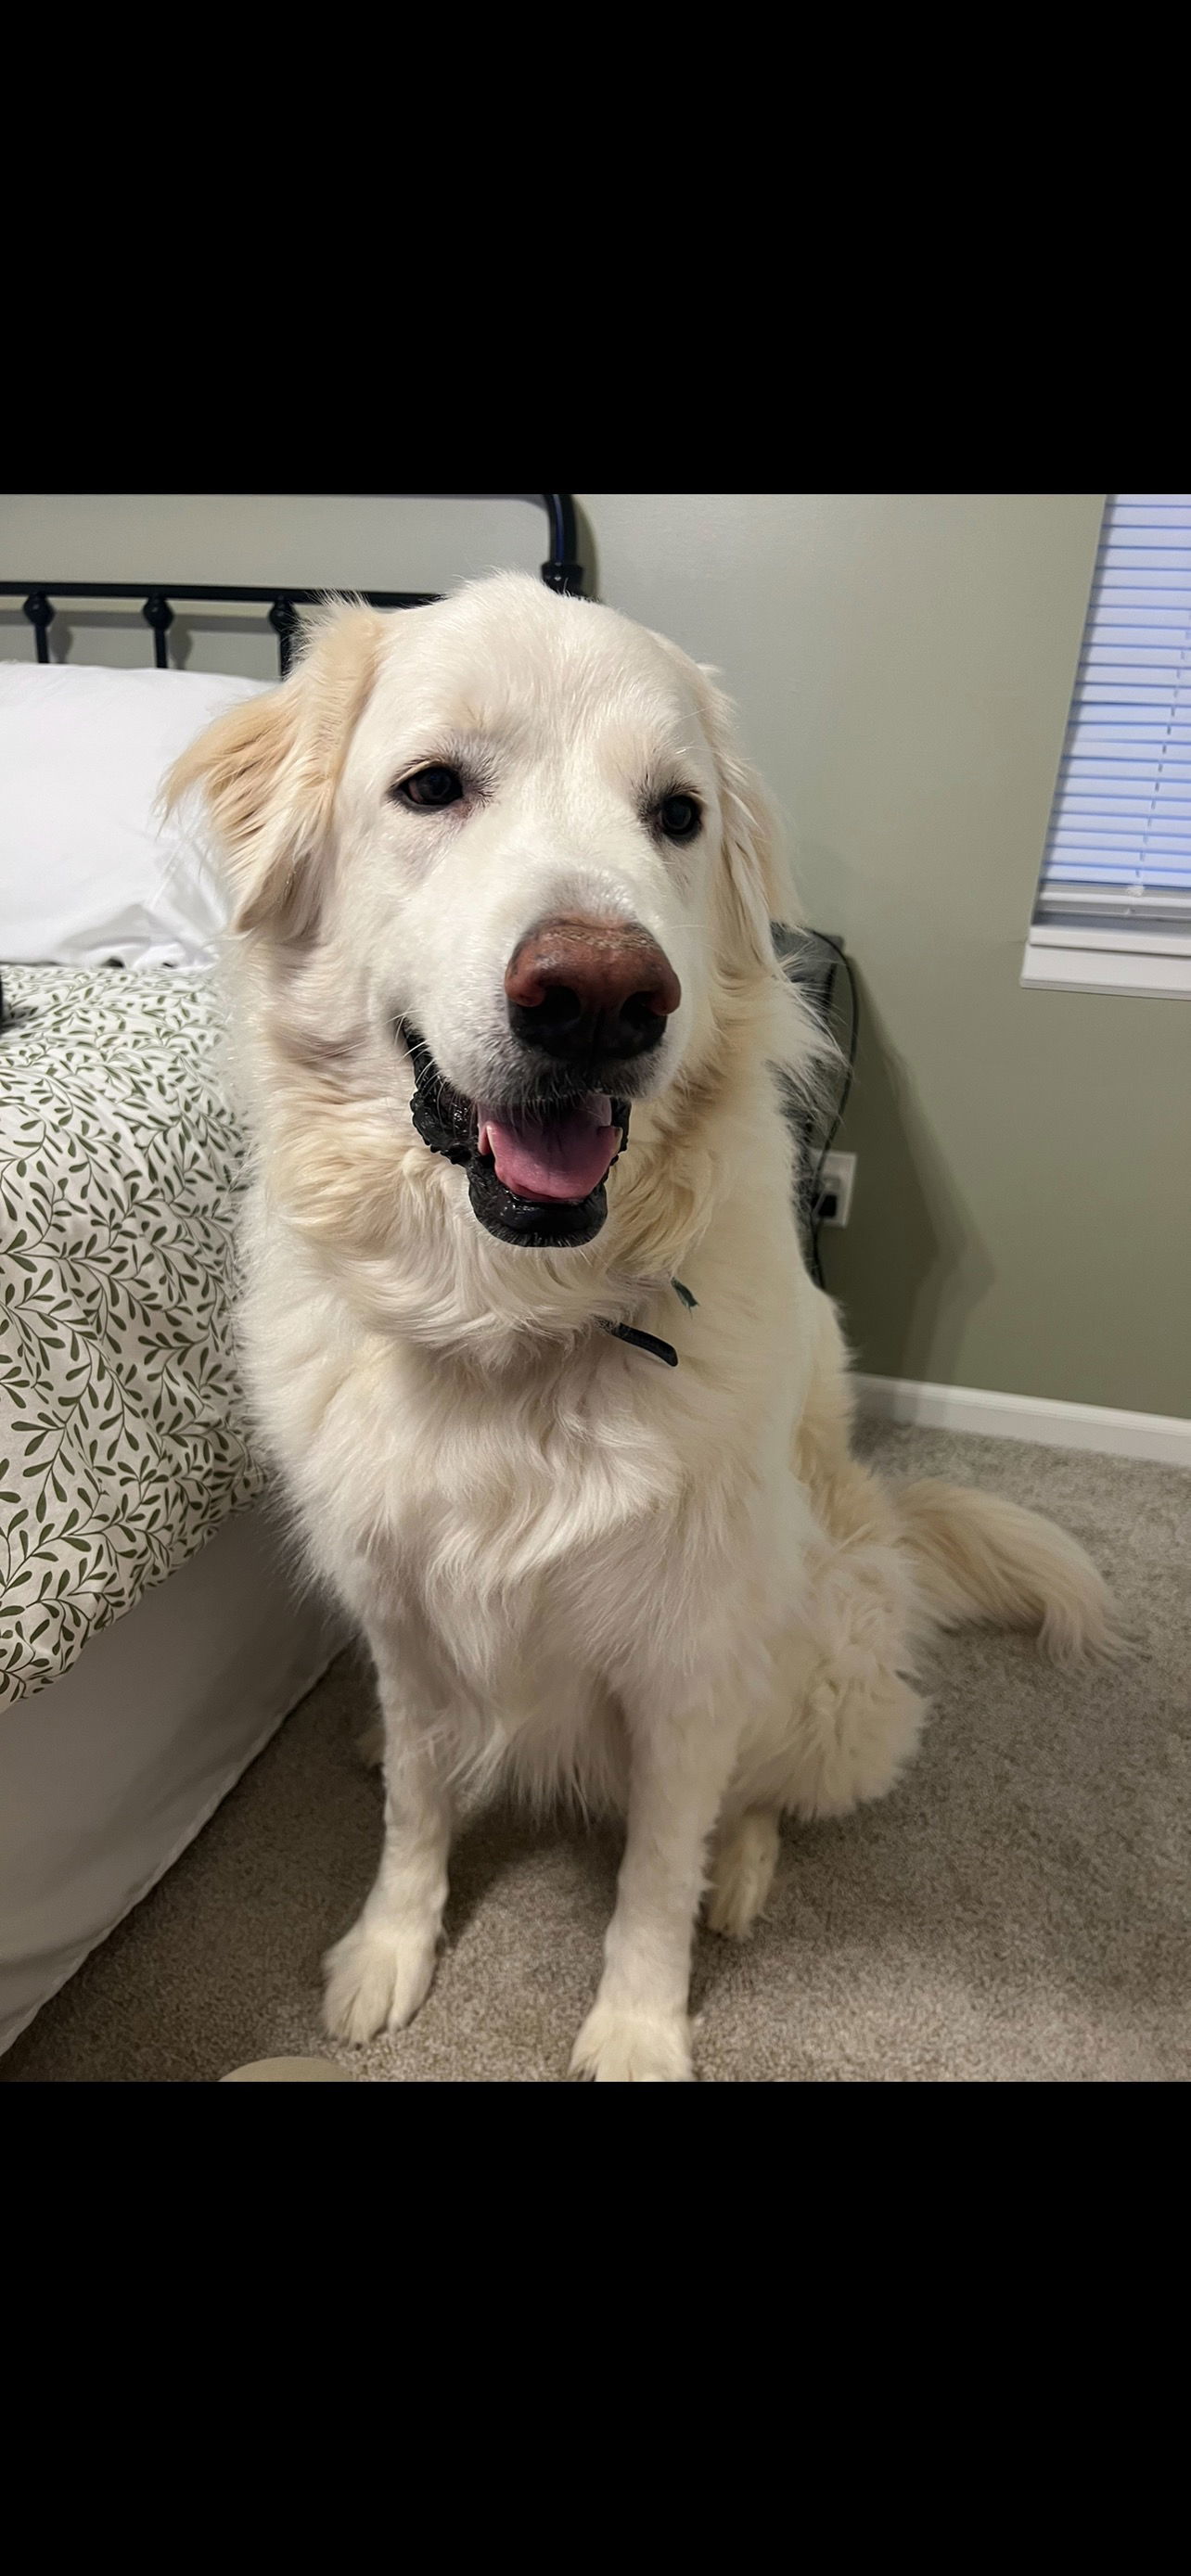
[0,1427,1191,2084]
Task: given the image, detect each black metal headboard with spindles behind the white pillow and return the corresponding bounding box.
[0,492,583,678]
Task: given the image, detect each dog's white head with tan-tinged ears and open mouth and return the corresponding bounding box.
[170,574,788,1247]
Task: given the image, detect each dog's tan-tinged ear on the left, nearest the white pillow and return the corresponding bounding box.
[162,608,387,937]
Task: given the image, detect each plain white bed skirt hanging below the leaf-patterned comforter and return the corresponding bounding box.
[0,1507,343,2050]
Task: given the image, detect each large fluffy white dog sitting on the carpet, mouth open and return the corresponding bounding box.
[170,574,1111,2082]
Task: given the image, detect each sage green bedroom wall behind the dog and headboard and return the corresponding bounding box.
[0,492,1191,1414]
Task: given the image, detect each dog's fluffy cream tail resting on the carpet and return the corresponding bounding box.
[892,1476,1124,1664]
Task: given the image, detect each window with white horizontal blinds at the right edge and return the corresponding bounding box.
[1021,492,1191,994]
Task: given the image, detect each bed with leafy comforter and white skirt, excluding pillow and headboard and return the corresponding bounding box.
[0,966,340,2048]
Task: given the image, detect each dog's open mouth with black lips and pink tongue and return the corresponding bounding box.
[404,1027,629,1249]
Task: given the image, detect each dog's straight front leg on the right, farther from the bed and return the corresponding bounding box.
[570,1692,737,2084]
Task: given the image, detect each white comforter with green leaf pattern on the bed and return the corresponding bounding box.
[0,966,263,1702]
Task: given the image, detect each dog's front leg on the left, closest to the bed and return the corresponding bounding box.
[322,1633,451,2040]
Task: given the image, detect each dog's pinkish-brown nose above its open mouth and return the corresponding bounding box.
[506,917,683,1064]
